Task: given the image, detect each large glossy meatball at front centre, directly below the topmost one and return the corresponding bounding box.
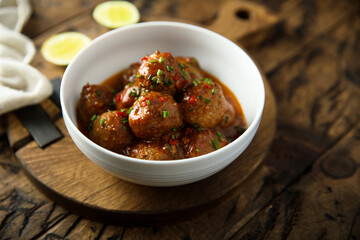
[129,92,182,139]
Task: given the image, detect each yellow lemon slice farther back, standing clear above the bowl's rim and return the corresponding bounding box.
[93,1,140,29]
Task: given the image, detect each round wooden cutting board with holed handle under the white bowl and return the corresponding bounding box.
[9,1,276,225]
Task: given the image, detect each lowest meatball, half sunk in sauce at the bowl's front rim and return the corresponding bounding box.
[128,141,175,160]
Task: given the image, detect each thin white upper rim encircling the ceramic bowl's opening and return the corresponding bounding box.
[60,21,265,166]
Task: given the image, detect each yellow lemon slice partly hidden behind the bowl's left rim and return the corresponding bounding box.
[41,32,91,66]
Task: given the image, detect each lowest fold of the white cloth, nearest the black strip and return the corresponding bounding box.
[0,59,53,115]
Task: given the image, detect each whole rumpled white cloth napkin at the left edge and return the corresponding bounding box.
[0,0,53,115]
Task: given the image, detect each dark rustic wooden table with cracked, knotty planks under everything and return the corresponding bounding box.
[0,0,360,239]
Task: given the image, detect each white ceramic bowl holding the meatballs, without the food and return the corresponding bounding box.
[61,22,265,186]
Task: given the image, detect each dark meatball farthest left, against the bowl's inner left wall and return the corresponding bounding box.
[78,84,114,124]
